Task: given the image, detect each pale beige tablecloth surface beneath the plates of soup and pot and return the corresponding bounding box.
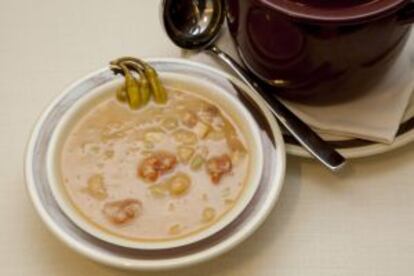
[0,0,414,276]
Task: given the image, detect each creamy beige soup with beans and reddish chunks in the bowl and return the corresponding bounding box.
[59,89,250,241]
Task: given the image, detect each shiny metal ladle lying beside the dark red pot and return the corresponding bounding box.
[162,0,345,171]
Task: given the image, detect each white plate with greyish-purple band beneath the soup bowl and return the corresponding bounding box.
[25,59,285,270]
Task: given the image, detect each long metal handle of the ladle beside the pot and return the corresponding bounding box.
[206,45,346,171]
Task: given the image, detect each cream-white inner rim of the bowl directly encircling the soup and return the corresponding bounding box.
[46,69,264,250]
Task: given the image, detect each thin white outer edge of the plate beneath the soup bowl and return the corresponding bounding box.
[24,58,286,271]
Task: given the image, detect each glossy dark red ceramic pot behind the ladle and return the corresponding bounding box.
[227,0,414,99]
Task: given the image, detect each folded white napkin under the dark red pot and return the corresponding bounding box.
[186,27,414,144]
